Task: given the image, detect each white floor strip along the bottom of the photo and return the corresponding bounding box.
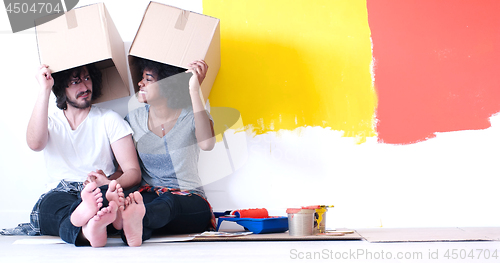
[0,236,500,263]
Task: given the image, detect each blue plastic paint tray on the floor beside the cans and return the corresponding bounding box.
[215,216,288,234]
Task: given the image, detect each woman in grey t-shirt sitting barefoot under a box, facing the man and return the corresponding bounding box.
[123,60,215,246]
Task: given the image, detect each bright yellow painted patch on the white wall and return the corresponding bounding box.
[203,0,377,142]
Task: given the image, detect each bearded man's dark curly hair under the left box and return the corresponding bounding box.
[52,64,102,110]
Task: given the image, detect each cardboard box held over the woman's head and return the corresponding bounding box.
[129,2,220,101]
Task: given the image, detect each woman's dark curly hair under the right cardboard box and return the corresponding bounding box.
[136,58,192,109]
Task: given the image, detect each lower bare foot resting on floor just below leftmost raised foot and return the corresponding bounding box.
[82,201,118,247]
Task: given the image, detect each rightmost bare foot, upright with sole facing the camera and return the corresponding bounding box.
[122,191,146,247]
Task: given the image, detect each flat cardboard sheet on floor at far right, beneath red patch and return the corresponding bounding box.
[356,227,500,243]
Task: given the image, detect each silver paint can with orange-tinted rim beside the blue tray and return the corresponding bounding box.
[286,208,315,236]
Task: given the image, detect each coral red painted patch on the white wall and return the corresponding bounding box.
[367,0,500,144]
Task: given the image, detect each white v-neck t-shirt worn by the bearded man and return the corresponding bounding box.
[44,106,133,187]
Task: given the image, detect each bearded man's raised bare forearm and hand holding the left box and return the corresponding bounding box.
[26,65,54,151]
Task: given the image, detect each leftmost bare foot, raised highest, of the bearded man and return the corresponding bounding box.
[70,182,103,227]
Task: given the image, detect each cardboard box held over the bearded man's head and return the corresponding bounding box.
[36,3,130,103]
